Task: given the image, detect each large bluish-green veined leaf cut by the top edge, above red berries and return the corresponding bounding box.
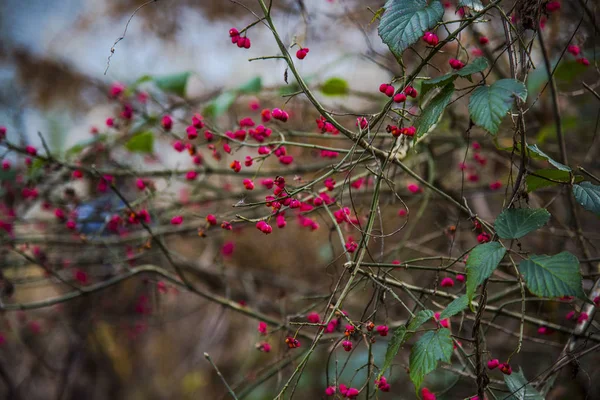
[379,0,444,56]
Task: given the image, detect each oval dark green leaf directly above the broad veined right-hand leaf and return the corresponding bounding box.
[494,208,550,239]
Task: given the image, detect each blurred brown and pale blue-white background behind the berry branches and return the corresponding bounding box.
[0,0,600,400]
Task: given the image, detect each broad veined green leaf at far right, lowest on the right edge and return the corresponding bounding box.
[519,251,585,298]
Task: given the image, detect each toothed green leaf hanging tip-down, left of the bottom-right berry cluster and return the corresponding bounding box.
[409,328,454,392]
